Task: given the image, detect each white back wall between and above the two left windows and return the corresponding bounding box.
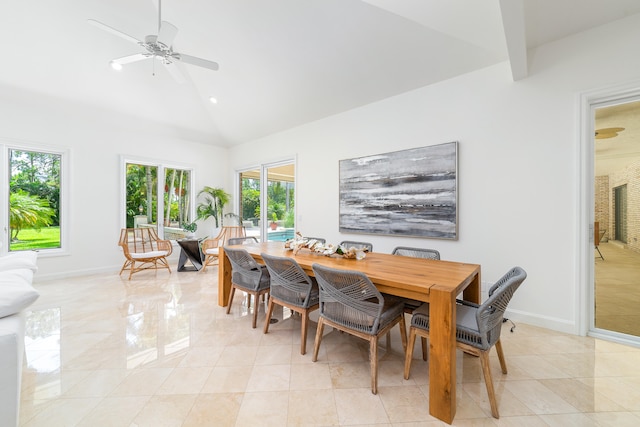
[0,87,228,279]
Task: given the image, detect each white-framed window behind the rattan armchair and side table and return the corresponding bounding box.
[125,161,195,240]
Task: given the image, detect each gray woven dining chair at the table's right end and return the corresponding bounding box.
[404,267,527,418]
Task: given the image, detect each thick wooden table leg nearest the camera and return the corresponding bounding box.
[429,285,456,424]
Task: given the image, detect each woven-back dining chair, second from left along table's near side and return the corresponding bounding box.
[262,253,319,354]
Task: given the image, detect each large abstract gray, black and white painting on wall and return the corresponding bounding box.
[340,142,458,240]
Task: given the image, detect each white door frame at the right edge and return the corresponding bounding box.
[576,80,640,346]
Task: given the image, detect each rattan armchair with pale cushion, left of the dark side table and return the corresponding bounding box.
[118,227,173,280]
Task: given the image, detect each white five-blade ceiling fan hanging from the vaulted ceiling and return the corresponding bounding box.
[87,0,219,83]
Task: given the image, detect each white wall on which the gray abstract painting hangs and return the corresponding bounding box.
[229,16,640,333]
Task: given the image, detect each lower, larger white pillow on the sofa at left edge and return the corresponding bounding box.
[0,269,40,318]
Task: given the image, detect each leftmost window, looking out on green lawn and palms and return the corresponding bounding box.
[7,148,63,251]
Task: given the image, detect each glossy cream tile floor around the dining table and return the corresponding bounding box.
[20,268,640,427]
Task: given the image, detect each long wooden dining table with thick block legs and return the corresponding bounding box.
[218,242,481,424]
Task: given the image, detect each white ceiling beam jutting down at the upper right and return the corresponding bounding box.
[500,0,529,81]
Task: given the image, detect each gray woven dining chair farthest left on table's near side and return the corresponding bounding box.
[224,246,270,329]
